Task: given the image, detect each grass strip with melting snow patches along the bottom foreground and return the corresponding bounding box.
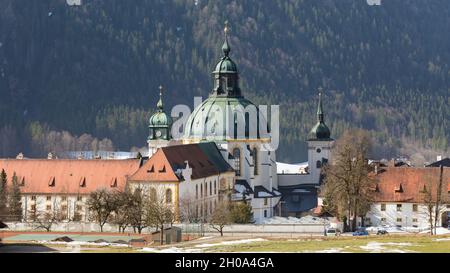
[0,235,450,253]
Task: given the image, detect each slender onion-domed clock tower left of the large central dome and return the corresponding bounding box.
[147,86,172,157]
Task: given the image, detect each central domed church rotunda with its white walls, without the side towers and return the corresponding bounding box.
[183,22,280,222]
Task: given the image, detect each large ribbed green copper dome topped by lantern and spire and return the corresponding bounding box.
[184,23,268,141]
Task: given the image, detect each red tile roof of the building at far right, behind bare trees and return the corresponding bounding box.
[374,167,450,203]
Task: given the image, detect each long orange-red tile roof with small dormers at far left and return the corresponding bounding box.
[0,159,140,194]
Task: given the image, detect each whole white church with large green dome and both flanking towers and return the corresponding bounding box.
[148,25,333,223]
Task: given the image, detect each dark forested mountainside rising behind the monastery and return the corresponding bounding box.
[0,0,450,161]
